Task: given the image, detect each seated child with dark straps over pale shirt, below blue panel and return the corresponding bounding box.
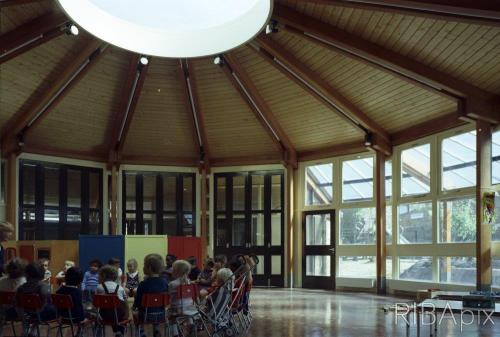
[96,264,129,337]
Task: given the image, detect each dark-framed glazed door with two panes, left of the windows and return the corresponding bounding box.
[302,210,335,289]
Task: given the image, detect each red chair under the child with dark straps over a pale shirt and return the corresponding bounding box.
[92,294,131,337]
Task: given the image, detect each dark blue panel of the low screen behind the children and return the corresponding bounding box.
[79,235,125,271]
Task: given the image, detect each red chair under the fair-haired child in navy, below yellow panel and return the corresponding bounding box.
[136,293,170,336]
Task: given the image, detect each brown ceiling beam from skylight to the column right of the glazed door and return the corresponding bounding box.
[257,35,391,155]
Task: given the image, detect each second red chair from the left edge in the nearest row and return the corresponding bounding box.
[17,294,57,337]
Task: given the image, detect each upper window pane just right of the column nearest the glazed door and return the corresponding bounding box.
[401,144,431,196]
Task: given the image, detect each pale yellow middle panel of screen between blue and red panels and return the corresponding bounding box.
[125,235,167,278]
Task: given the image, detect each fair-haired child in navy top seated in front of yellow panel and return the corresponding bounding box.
[132,254,168,337]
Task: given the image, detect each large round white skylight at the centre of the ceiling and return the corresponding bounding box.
[58,0,272,57]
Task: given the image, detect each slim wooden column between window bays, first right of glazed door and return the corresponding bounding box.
[375,151,387,294]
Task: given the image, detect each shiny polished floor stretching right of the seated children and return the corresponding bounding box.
[248,289,500,337]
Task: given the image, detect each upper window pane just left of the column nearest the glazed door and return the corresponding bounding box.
[342,157,373,201]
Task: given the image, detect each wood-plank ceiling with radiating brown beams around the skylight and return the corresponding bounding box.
[0,0,500,166]
